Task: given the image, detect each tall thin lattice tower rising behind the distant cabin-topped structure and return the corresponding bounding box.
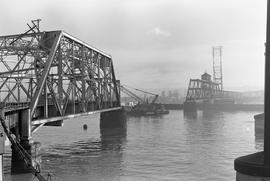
[212,46,223,91]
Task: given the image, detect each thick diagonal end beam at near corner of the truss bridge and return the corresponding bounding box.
[30,31,62,119]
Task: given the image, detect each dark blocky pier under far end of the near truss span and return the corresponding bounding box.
[99,109,127,129]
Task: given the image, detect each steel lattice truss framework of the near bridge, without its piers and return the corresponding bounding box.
[0,22,120,125]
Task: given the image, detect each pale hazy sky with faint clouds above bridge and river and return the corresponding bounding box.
[0,0,266,90]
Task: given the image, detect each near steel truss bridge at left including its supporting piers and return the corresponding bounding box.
[0,20,125,177]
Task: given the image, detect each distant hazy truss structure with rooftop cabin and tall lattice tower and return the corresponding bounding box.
[184,46,241,111]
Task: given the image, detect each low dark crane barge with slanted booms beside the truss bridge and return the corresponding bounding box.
[120,85,169,116]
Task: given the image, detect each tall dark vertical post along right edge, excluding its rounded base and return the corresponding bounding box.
[264,0,270,165]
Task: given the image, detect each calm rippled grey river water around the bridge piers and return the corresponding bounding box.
[4,110,263,181]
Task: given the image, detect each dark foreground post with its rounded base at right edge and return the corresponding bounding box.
[234,0,270,181]
